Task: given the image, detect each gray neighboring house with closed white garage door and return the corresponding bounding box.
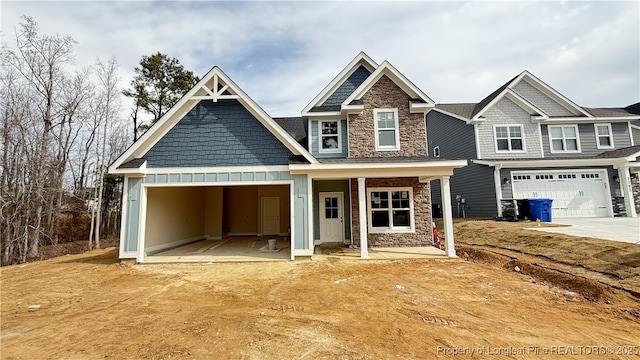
[426,71,640,218]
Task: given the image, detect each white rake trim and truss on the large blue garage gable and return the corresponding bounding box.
[109,66,318,172]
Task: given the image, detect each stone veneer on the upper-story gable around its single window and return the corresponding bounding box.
[348,75,427,158]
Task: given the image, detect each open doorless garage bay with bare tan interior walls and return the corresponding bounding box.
[144,185,291,262]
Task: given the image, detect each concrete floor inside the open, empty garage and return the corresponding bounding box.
[144,236,291,263]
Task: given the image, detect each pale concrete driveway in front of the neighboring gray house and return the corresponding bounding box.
[531,217,640,244]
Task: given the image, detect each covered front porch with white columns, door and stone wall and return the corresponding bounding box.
[290,158,466,258]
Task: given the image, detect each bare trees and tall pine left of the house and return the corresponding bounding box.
[0,16,198,265]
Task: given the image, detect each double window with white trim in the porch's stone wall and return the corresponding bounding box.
[367,187,415,233]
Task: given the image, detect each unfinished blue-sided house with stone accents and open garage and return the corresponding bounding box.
[109,53,467,262]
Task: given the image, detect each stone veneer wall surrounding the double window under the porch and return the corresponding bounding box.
[351,178,433,247]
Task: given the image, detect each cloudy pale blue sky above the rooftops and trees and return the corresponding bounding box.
[0,0,640,117]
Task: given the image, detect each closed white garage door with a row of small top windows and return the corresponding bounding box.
[511,170,611,218]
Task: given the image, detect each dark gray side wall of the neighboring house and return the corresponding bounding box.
[426,111,497,216]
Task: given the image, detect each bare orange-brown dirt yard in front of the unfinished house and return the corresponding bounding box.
[0,222,640,359]
